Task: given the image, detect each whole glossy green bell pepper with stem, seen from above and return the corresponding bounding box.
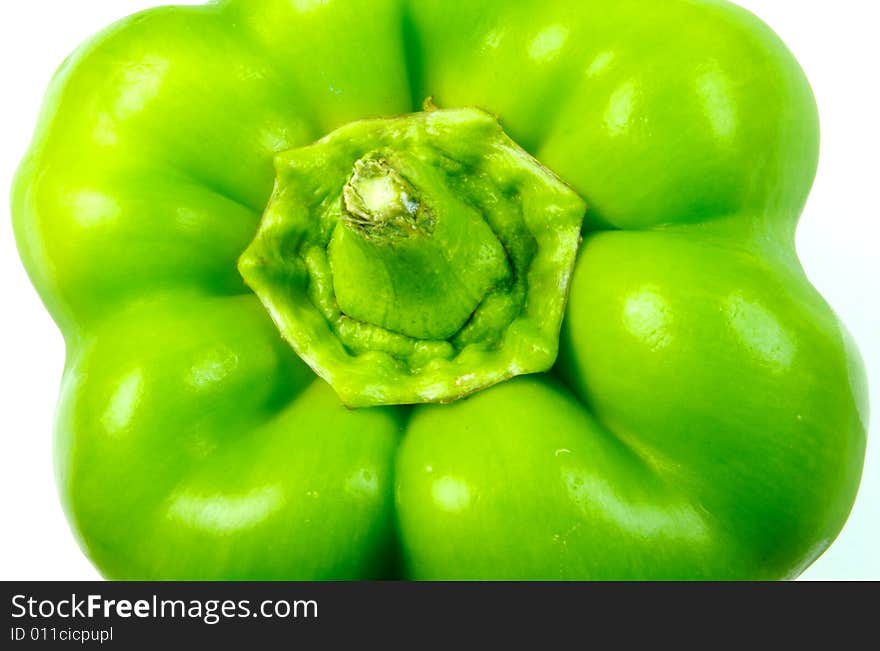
[13,0,868,579]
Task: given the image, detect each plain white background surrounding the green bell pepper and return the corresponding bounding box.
[0,0,880,580]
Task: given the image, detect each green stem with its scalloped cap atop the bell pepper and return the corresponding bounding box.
[239,109,585,407]
